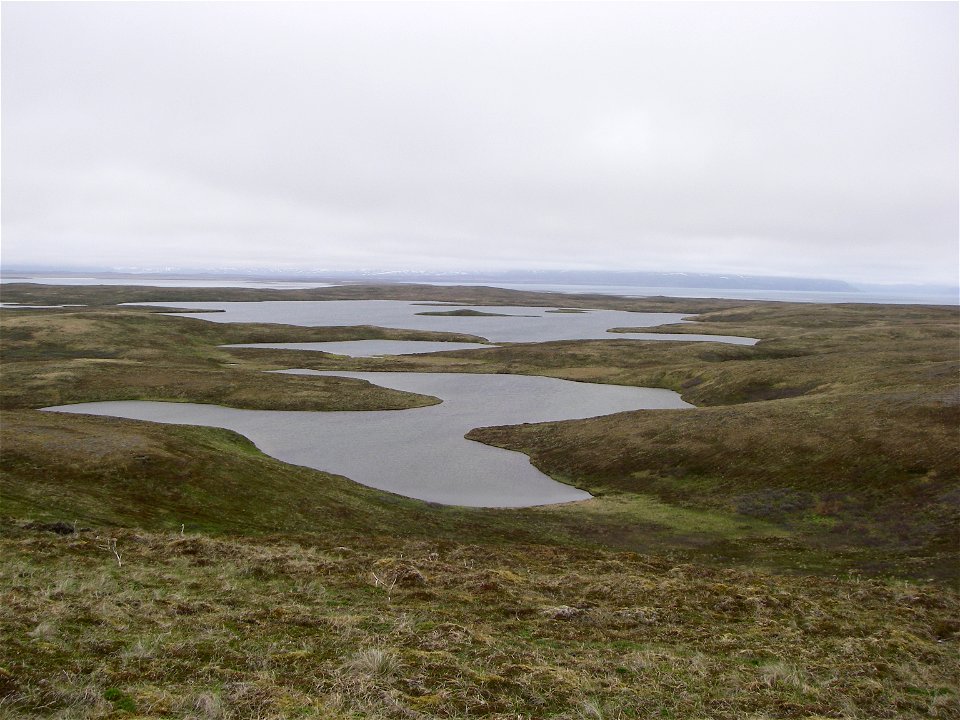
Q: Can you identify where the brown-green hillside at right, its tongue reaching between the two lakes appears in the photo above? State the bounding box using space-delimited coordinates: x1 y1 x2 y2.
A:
216 296 960 581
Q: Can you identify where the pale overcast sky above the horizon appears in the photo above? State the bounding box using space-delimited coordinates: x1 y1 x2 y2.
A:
2 2 960 283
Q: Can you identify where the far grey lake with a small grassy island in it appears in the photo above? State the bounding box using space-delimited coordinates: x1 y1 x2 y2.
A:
133 300 757 349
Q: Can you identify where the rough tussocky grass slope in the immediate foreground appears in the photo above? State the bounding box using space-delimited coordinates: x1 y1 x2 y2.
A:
0 523 960 719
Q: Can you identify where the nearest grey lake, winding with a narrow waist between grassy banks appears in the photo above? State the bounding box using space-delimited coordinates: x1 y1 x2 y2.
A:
44 370 693 507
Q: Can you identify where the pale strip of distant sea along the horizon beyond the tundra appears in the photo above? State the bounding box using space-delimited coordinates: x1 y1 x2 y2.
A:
0 274 960 305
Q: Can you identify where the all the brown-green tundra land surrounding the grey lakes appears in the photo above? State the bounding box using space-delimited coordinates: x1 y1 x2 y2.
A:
0 285 960 720
